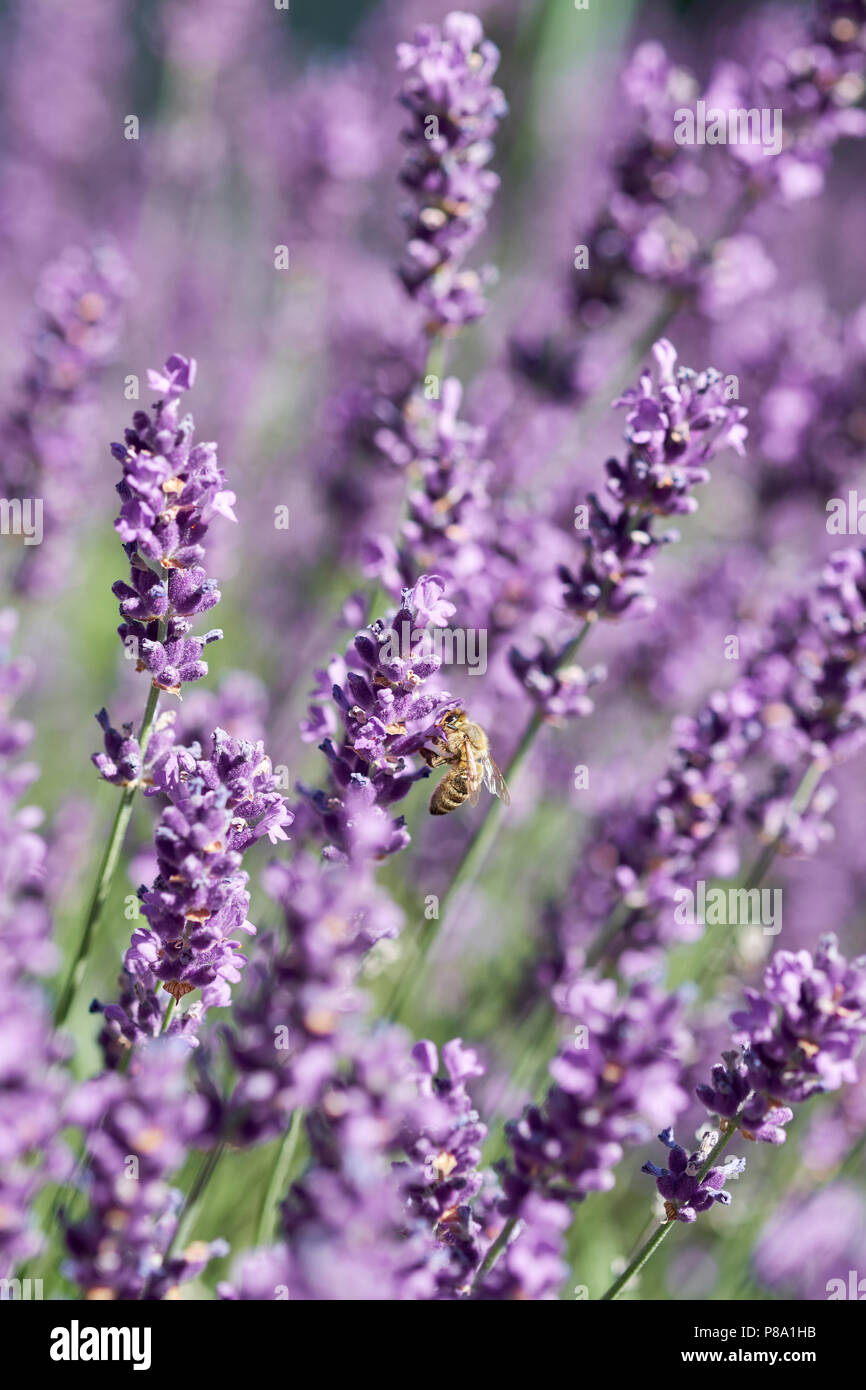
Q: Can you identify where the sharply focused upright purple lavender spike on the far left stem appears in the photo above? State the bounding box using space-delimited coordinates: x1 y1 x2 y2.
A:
111 353 236 695
